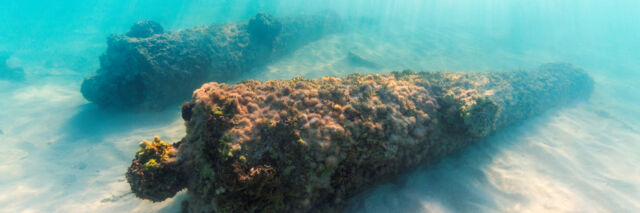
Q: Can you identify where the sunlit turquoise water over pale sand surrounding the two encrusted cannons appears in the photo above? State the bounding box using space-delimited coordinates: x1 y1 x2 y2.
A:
0 0 640 212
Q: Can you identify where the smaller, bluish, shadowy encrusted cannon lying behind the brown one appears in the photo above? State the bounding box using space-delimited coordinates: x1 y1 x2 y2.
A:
81 12 341 109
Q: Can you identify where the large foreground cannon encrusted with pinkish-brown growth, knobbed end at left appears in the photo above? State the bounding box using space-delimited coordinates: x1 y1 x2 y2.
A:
126 64 593 212
